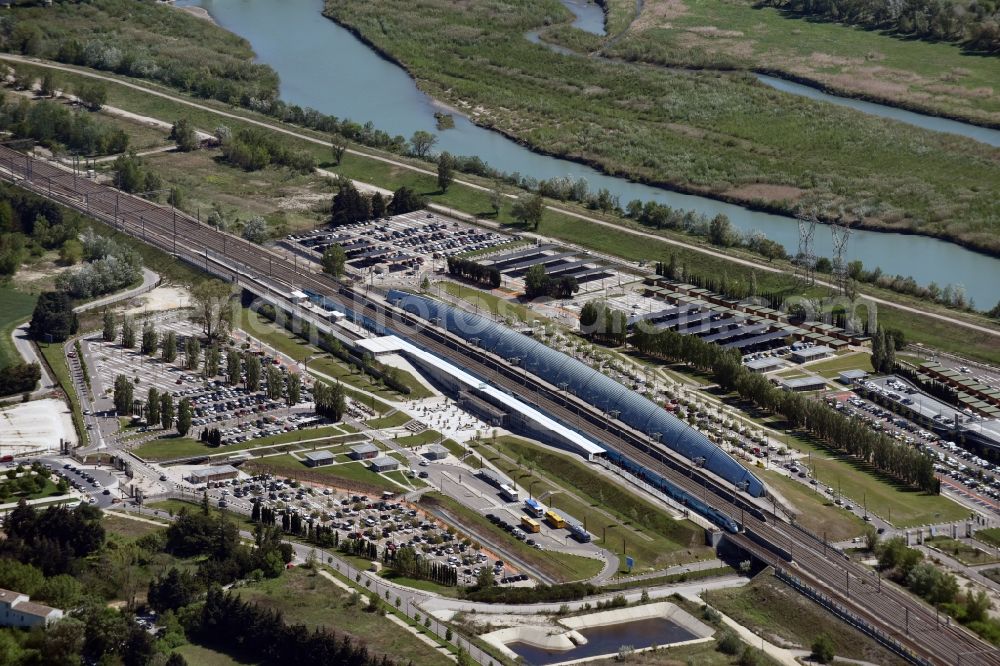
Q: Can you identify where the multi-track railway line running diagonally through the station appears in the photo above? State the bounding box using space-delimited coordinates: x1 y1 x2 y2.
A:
0 146 1000 666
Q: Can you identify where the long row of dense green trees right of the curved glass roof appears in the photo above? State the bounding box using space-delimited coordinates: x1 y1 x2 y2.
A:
630 326 940 493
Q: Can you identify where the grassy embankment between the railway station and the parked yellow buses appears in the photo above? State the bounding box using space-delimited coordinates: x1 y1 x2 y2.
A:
488 436 713 571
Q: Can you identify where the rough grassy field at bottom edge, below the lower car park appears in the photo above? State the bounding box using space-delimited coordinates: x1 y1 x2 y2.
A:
236 568 452 666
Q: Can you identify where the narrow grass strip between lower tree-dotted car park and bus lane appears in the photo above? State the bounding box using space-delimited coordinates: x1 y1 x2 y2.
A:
420 492 603 582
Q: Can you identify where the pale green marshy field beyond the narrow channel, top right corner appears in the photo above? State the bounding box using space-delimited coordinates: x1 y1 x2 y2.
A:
600 0 1000 123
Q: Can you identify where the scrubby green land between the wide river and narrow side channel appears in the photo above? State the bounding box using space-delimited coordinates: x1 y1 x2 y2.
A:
326 0 1000 252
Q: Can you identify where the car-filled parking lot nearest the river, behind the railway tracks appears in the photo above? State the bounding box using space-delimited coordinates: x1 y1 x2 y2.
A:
287 210 519 272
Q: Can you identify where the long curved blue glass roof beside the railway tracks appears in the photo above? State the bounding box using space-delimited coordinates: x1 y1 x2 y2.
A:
388 290 764 497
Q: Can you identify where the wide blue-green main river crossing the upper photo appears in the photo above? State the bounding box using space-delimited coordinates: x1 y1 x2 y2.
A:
177 0 1000 307
